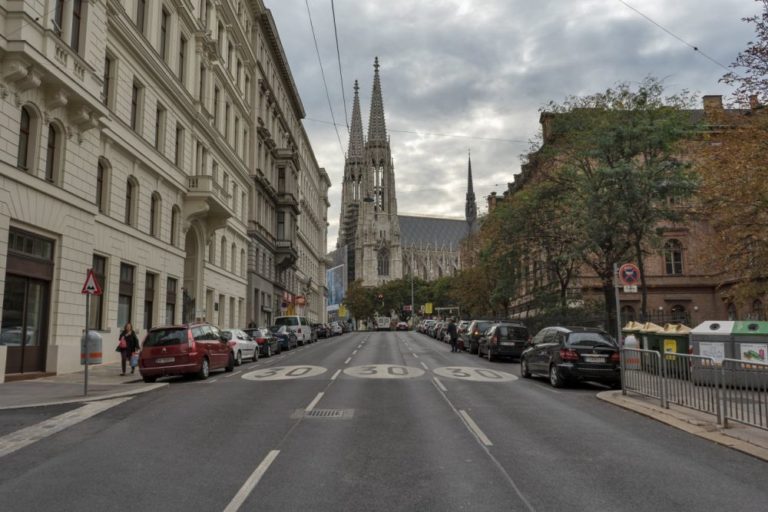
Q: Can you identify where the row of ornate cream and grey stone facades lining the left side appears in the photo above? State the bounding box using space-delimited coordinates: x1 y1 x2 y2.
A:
0 0 327 381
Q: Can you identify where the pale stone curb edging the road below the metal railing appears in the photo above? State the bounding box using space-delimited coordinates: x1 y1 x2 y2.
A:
597 391 768 462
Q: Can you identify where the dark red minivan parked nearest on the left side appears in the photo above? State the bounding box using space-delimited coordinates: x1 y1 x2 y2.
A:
139 323 235 382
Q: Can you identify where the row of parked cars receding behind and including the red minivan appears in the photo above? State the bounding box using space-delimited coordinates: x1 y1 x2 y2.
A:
139 316 342 382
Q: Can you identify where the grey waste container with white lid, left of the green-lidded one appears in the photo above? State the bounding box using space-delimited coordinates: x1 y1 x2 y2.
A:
689 320 736 384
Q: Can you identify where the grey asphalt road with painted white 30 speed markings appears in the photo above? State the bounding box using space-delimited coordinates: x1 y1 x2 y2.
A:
0 332 768 512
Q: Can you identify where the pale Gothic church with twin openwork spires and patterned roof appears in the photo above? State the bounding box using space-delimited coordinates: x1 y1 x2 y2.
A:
331 57 477 286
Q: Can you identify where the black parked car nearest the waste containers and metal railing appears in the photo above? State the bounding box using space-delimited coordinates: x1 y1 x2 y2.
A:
520 327 621 388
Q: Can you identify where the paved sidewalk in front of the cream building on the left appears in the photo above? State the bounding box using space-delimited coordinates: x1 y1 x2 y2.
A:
0 363 168 410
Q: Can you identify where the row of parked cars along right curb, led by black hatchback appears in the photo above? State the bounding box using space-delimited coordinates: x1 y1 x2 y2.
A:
417 319 621 387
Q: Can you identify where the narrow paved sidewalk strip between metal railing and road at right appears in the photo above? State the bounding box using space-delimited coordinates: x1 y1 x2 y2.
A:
597 391 768 462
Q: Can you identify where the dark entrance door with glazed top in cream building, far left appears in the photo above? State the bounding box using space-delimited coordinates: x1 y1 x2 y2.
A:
0 274 50 374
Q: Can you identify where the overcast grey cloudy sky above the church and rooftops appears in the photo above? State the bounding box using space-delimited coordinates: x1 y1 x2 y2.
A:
265 0 762 249
